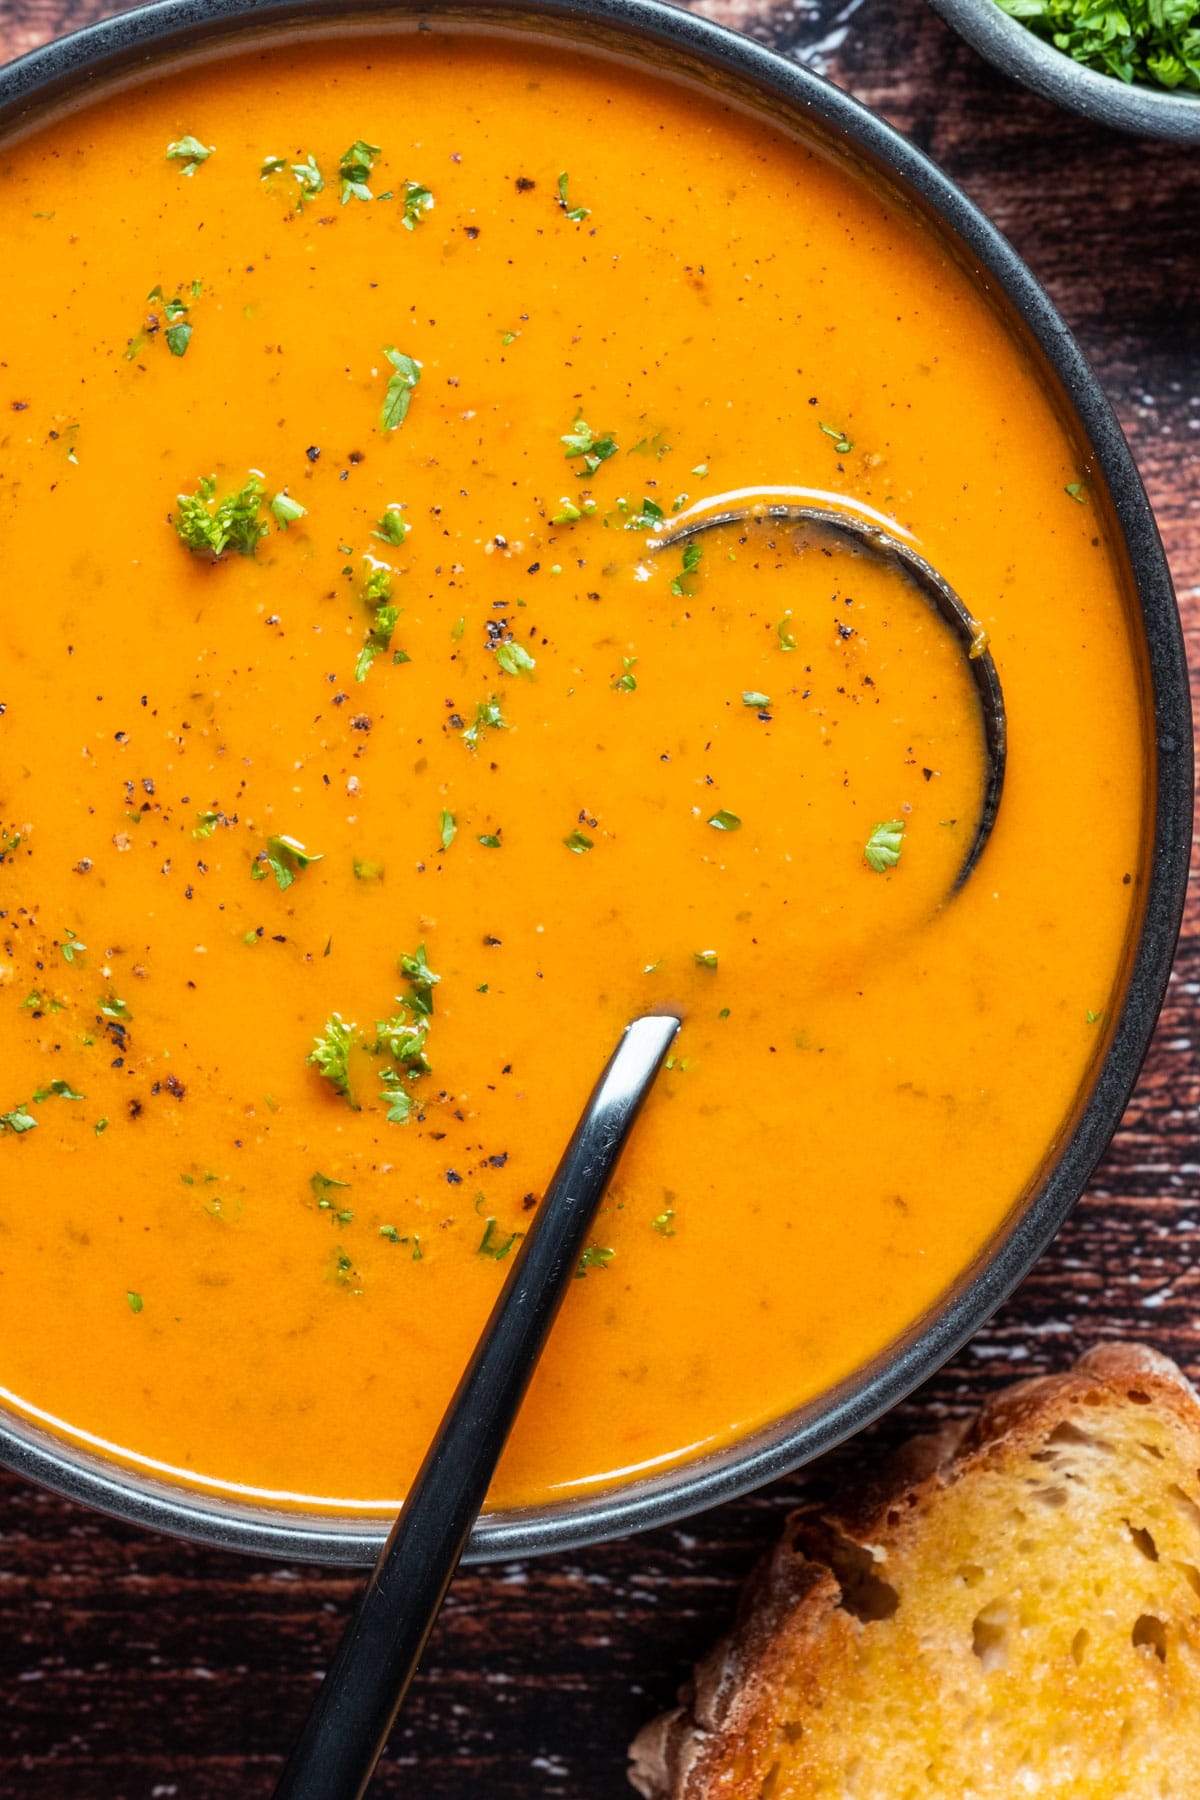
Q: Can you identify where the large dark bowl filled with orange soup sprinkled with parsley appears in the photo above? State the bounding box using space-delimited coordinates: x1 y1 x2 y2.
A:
0 0 1191 1561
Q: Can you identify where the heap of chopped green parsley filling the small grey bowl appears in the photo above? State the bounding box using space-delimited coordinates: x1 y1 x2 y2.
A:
999 0 1200 92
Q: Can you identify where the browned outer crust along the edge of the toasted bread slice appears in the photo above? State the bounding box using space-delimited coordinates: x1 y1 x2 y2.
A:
630 1343 1200 1800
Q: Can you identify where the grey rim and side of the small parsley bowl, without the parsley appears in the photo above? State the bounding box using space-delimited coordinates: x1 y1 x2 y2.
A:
930 0 1200 144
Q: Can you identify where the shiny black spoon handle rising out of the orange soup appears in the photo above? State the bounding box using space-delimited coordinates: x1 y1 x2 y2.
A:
275 1013 680 1800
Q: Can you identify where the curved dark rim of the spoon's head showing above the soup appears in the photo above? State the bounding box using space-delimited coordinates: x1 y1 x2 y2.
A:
646 488 1007 895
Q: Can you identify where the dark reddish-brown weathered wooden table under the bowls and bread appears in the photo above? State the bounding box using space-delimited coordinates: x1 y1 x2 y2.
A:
0 0 1200 1800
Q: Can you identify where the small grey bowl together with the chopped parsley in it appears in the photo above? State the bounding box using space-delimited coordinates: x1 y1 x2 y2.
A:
932 0 1200 142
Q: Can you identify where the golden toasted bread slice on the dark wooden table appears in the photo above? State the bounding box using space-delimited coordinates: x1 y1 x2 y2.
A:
630 1345 1200 1800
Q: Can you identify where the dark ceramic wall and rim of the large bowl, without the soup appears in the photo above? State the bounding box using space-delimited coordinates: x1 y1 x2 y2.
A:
0 0 1191 1562
